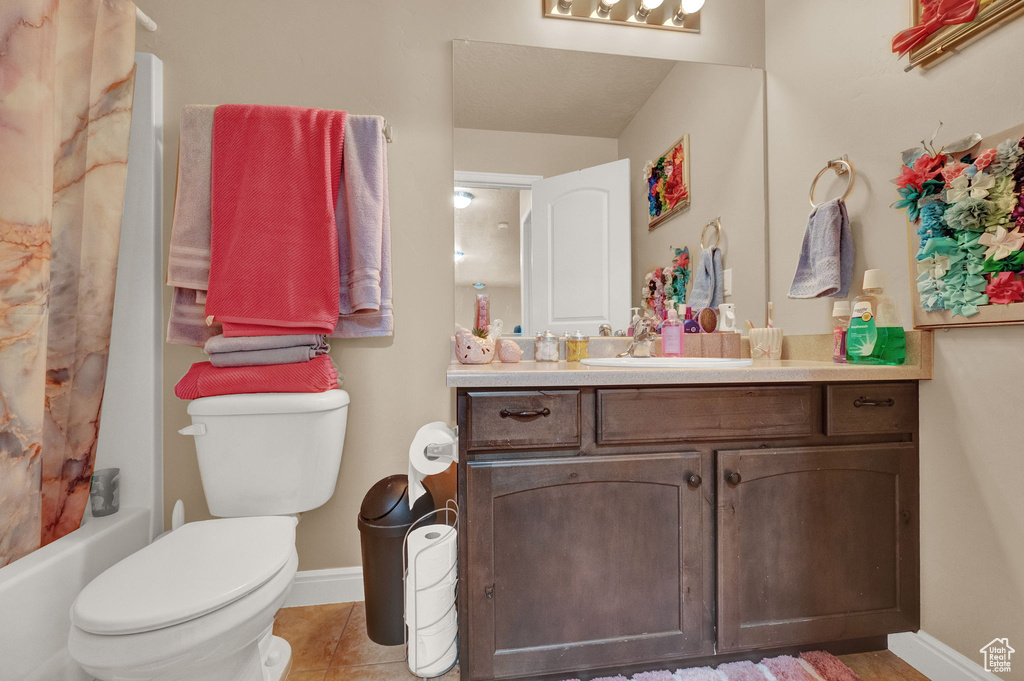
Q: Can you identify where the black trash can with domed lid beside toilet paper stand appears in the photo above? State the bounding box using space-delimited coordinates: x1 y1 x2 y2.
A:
358 475 434 645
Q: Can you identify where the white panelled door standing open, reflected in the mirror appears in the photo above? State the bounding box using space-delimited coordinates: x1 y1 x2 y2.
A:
523 159 630 335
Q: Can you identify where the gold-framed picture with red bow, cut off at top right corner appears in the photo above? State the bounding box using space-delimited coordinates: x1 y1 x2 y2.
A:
893 0 1024 71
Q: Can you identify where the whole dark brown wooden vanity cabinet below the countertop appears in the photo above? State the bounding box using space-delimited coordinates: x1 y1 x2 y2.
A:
458 381 919 681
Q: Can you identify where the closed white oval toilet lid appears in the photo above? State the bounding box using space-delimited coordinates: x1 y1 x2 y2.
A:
72 516 296 634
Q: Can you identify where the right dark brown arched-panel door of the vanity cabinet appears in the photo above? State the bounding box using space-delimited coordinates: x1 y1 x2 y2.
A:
717 442 920 651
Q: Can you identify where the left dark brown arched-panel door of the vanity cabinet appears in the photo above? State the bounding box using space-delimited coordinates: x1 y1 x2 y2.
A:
460 454 707 679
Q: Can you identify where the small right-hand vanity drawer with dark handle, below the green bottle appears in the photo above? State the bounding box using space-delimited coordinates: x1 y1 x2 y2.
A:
825 383 918 435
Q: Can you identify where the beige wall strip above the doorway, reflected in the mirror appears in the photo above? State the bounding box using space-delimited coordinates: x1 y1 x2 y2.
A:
455 128 618 177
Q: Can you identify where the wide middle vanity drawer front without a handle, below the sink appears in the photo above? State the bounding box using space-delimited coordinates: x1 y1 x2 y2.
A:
597 385 820 443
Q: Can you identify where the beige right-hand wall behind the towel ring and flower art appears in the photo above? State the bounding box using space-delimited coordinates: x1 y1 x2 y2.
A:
766 0 1024 679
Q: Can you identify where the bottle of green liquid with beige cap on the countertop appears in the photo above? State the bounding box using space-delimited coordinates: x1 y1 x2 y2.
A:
846 269 906 367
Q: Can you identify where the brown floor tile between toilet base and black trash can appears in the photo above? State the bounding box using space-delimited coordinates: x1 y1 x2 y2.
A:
273 603 352 681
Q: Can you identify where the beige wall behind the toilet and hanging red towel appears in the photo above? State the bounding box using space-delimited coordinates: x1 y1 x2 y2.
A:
137 0 764 569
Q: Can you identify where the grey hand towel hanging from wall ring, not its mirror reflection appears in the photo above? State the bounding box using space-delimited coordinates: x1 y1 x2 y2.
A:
790 199 853 298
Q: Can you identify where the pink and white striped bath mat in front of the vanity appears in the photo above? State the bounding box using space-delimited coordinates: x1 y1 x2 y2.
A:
566 650 863 681
